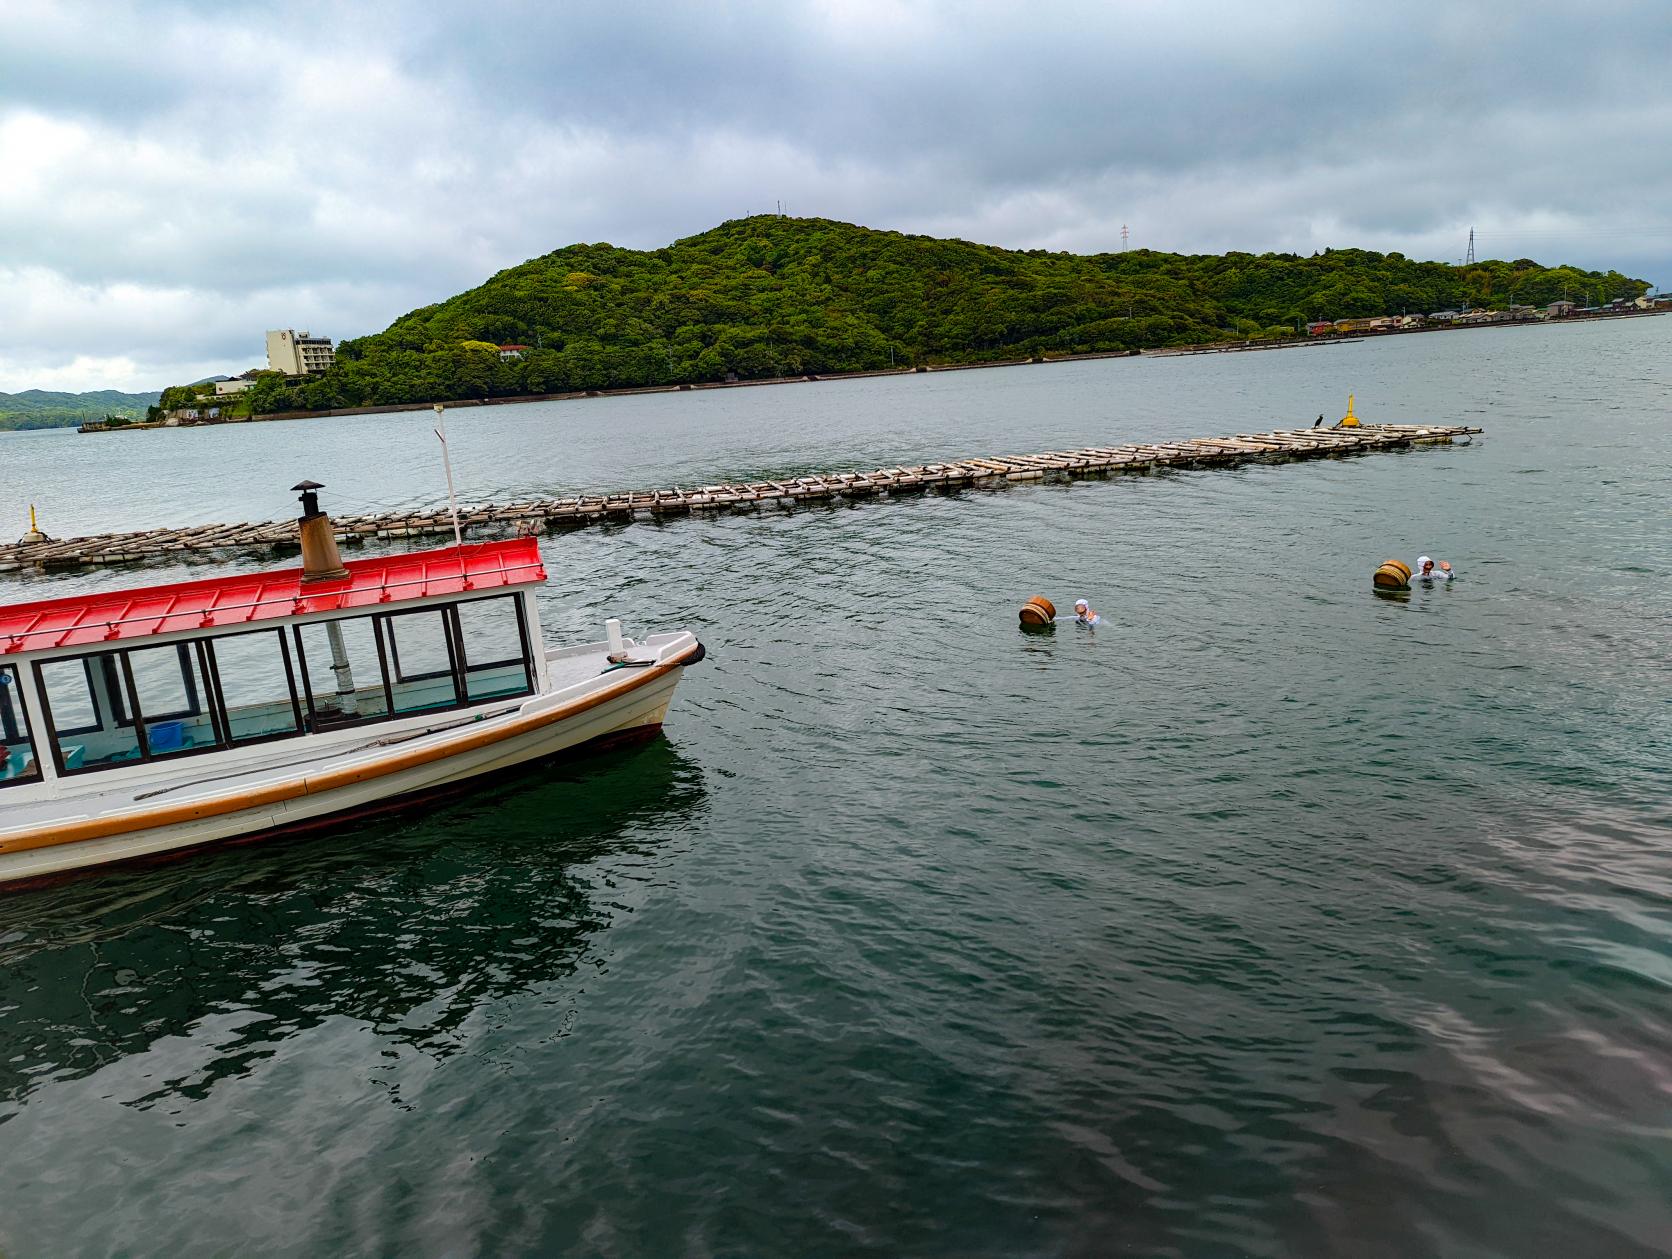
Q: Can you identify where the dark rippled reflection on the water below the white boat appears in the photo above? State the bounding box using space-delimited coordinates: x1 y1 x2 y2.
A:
0 739 706 1122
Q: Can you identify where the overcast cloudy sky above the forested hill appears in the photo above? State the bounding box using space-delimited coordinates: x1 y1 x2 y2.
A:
0 0 1672 391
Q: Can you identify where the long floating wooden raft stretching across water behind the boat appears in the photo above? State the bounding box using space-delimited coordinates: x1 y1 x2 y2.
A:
0 425 1481 572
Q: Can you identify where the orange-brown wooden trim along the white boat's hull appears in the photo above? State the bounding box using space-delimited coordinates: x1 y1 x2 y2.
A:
0 644 702 879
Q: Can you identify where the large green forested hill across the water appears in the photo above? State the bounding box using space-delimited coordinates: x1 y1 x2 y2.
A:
251 216 1649 411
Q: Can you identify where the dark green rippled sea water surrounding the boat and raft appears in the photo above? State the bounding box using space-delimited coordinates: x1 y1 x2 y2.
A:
0 319 1672 1259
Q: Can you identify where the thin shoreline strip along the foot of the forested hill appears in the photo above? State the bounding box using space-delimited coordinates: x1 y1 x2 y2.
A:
65 311 1672 433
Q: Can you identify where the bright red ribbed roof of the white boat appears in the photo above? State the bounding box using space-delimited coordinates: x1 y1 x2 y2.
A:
0 538 545 655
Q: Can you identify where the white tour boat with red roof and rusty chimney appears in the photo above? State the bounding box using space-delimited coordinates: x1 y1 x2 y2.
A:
0 483 704 883
